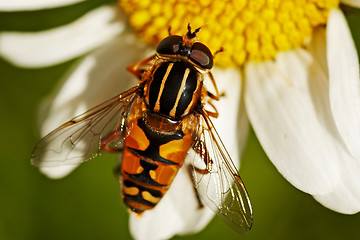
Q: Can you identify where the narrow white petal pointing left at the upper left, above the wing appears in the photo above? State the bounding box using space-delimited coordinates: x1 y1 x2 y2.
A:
0 6 125 67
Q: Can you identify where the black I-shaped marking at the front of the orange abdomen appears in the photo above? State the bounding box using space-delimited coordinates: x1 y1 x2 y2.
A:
128 118 184 165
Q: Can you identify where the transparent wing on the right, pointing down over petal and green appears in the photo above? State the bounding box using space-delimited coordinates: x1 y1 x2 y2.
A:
191 112 253 233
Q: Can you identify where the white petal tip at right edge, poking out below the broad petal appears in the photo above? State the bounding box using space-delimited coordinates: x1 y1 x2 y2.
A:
314 150 360 214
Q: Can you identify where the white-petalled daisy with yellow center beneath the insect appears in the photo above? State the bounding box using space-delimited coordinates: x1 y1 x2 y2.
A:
0 0 360 239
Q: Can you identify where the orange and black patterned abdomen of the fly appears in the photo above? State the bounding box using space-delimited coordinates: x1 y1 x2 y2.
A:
121 117 193 213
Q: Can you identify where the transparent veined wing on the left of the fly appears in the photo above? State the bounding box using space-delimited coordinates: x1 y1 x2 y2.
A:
31 86 139 167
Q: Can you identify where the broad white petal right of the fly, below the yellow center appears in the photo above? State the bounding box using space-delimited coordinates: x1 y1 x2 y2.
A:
245 49 344 194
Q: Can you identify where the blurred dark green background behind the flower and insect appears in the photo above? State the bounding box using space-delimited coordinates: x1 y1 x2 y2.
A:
0 0 360 240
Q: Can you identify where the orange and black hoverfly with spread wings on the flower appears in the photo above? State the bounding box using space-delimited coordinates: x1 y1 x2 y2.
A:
32 24 252 232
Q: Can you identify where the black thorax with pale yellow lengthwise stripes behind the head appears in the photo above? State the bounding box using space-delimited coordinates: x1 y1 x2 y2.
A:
145 62 202 119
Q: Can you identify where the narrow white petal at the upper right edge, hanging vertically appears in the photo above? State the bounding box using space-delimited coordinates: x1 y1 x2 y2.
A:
327 9 360 158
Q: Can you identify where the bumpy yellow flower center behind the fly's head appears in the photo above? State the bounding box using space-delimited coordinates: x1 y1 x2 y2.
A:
120 0 339 67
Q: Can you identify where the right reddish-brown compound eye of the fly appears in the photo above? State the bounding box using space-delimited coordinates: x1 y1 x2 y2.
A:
189 42 213 69
